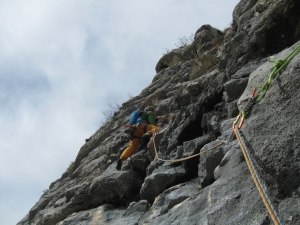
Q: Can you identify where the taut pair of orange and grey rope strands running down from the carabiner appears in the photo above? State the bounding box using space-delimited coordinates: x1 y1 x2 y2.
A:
232 124 281 225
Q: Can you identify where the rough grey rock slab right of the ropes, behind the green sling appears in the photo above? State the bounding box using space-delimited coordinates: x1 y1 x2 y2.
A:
238 42 300 224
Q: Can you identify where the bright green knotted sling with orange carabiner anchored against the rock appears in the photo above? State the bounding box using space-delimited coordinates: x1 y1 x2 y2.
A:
237 45 300 129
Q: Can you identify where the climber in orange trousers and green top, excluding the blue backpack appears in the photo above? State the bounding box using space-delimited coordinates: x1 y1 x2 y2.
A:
116 106 162 170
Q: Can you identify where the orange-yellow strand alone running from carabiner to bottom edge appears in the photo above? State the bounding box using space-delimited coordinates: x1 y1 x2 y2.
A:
232 124 279 225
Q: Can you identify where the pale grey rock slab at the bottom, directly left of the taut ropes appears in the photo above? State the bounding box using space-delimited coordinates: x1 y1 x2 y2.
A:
207 141 266 224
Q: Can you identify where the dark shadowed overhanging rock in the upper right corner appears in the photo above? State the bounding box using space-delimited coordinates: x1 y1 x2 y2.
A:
219 0 300 78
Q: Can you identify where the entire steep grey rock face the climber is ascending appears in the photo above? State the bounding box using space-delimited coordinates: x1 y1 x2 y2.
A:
18 0 300 225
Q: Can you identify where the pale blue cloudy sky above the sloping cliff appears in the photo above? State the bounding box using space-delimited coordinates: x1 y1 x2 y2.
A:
0 0 239 225
